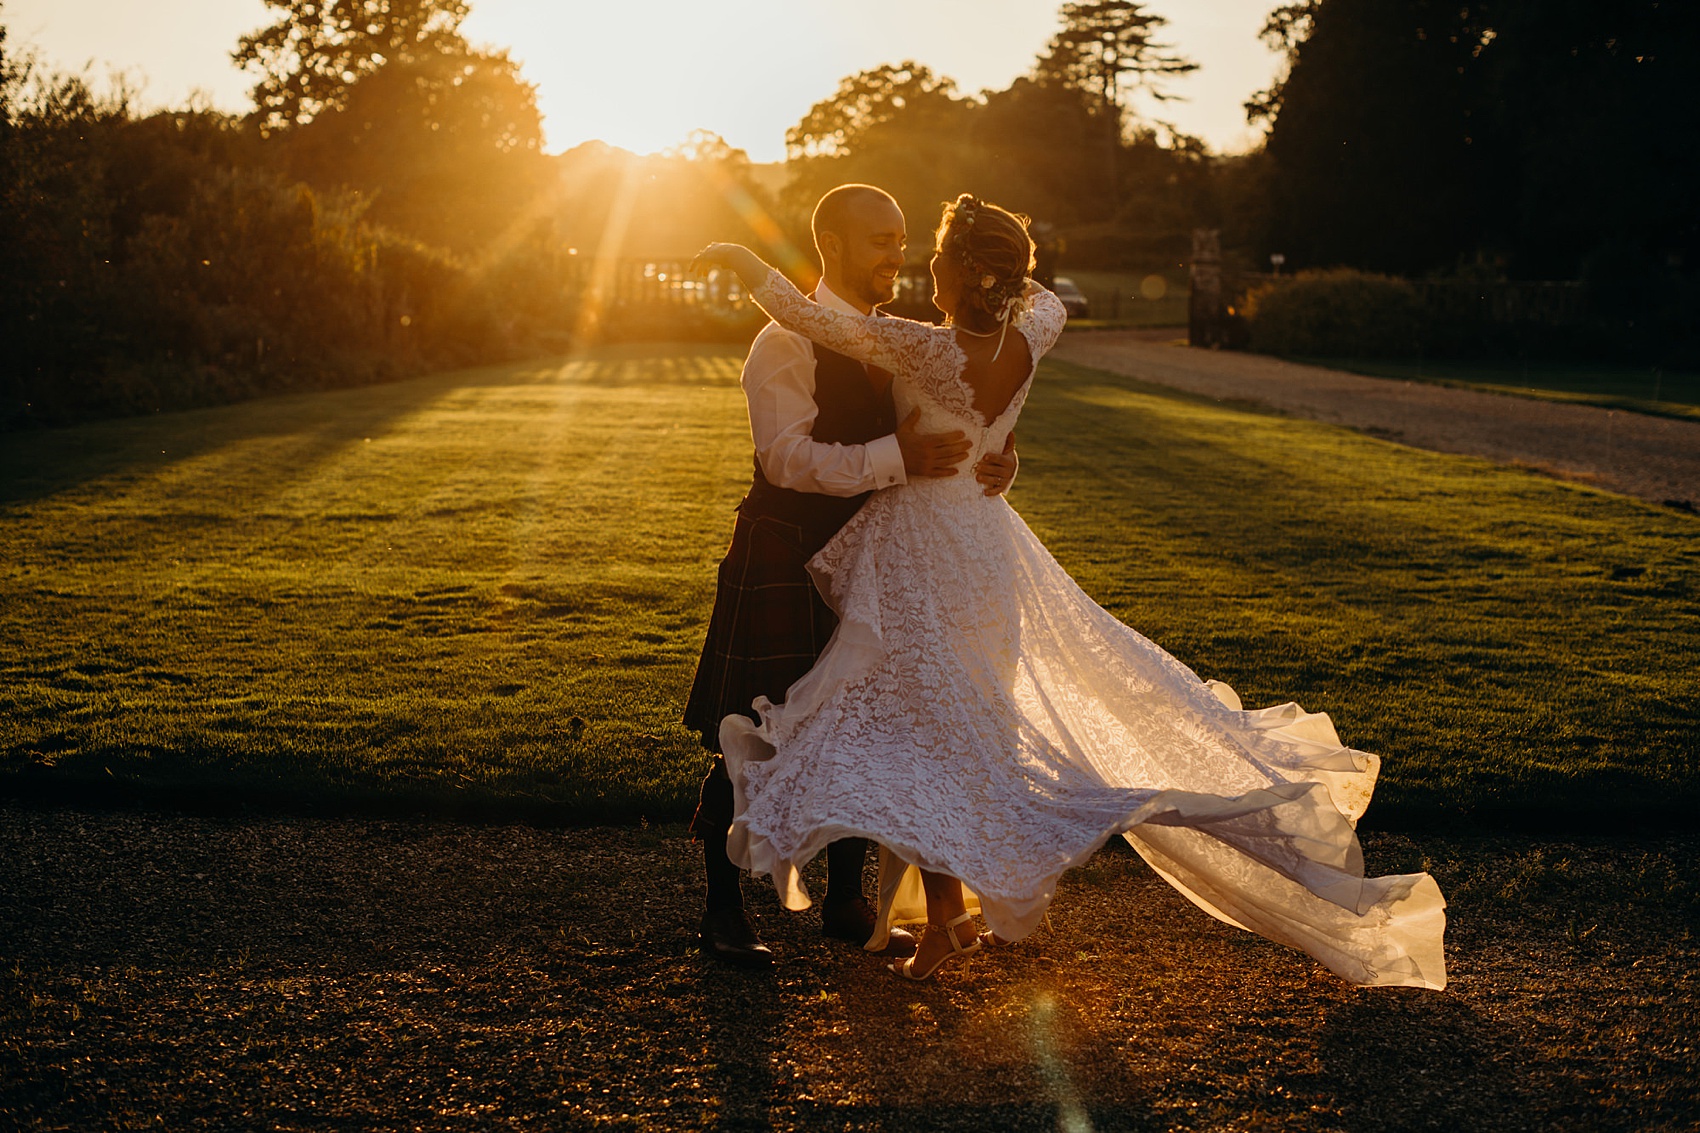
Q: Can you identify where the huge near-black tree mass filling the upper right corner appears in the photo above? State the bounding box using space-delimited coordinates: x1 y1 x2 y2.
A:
1248 0 1700 279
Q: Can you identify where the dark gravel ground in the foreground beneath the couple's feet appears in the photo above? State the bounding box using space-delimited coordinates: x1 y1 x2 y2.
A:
0 805 1700 1133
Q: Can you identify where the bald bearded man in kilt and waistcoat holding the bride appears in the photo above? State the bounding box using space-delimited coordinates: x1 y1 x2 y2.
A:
685 185 1017 966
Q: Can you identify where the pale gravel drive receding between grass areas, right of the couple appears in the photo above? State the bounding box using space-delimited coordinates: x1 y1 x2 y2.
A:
1052 330 1700 507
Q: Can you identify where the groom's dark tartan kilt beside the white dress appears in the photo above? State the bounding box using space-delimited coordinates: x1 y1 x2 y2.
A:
685 509 842 752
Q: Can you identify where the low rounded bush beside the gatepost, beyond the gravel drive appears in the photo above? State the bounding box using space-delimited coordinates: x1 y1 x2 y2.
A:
1244 269 1425 357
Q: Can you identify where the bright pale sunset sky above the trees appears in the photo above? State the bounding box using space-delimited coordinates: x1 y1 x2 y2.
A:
0 0 1278 162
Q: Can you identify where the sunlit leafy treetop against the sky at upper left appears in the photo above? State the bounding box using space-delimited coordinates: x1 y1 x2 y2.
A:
231 0 471 131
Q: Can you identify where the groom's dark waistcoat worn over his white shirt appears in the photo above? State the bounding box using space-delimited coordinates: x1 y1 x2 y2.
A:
738 344 898 555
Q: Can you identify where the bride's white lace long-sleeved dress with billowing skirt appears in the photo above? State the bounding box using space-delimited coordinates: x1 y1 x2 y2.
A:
721 272 1445 988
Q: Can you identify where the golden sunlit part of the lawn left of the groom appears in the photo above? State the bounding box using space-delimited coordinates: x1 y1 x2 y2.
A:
0 347 748 817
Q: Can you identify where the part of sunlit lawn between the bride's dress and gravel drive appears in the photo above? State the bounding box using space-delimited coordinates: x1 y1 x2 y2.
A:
1017 364 1700 822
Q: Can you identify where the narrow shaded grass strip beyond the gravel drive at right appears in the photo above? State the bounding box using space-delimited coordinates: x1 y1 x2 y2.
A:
1297 357 1700 420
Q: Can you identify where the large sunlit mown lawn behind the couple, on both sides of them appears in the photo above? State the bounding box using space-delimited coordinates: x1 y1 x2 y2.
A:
0 345 1700 830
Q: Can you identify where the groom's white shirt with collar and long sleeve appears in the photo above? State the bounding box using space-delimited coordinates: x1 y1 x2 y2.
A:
740 281 906 495
